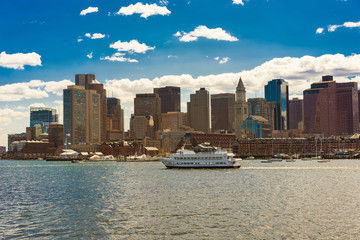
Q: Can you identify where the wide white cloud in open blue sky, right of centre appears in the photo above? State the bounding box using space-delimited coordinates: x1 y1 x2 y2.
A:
174 25 239 42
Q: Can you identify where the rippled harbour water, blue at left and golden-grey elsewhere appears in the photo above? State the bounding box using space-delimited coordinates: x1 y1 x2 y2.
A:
0 160 360 239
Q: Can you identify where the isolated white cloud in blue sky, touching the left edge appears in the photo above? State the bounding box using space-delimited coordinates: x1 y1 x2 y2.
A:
0 52 41 69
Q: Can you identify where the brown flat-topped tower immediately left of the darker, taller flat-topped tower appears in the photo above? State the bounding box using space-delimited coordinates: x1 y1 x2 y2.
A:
134 93 161 131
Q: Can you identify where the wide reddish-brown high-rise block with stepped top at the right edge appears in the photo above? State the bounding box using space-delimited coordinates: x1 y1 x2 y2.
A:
304 76 359 137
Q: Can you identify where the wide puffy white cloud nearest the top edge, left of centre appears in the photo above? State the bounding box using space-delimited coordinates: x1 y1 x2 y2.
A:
116 2 171 18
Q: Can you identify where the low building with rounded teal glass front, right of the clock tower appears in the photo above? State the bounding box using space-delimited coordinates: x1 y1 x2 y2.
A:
242 115 271 138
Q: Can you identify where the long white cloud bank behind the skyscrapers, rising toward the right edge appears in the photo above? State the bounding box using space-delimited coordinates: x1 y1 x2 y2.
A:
105 54 360 103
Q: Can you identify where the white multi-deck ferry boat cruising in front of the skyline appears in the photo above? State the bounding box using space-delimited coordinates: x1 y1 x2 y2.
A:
161 143 241 168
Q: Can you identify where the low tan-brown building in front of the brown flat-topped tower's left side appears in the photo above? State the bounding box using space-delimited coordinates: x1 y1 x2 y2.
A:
130 114 155 139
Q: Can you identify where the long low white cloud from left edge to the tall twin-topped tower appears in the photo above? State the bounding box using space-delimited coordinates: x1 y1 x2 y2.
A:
0 79 73 102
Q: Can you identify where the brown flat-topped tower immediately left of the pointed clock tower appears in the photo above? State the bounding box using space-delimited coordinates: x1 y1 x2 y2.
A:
211 93 235 132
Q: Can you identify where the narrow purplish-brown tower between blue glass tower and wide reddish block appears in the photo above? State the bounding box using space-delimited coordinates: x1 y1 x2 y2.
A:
289 98 304 129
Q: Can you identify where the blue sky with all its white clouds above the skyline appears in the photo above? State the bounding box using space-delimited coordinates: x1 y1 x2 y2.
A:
0 0 360 146
